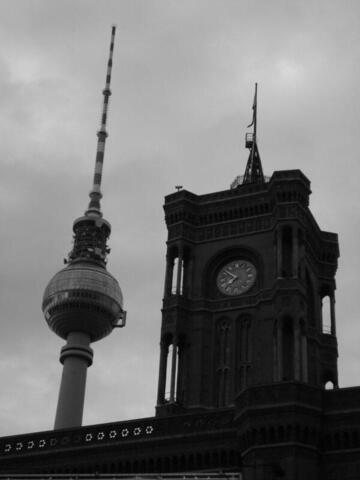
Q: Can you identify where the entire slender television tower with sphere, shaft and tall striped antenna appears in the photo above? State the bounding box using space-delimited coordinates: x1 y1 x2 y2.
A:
42 27 125 429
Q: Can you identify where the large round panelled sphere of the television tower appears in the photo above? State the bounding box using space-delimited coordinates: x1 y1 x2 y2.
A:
42 260 123 342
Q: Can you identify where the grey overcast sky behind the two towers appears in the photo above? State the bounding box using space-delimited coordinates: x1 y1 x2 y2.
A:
0 0 360 435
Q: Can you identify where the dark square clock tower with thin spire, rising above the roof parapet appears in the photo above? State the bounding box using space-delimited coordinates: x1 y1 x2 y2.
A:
157 86 339 416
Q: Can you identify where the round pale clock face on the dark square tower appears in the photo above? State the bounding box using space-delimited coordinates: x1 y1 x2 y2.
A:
216 260 256 295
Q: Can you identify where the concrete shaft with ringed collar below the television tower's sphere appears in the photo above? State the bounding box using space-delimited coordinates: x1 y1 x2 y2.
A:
54 332 93 430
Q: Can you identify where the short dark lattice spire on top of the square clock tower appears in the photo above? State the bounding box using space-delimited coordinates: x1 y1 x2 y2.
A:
243 83 265 183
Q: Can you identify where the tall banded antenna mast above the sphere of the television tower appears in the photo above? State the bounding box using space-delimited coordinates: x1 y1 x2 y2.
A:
86 25 116 217
